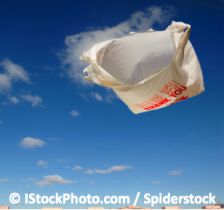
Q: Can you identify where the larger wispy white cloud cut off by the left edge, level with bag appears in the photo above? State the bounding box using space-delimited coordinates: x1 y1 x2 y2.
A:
0 59 30 93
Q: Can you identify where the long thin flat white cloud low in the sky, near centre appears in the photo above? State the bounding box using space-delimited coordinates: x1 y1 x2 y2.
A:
85 165 132 175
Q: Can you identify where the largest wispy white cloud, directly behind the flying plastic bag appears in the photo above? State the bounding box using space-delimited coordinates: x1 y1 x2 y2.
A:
60 6 174 84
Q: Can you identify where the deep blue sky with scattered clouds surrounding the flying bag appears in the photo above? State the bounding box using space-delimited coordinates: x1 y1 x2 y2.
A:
0 0 224 208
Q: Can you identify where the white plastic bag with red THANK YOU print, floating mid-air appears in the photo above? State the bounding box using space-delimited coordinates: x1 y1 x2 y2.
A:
81 21 204 114
